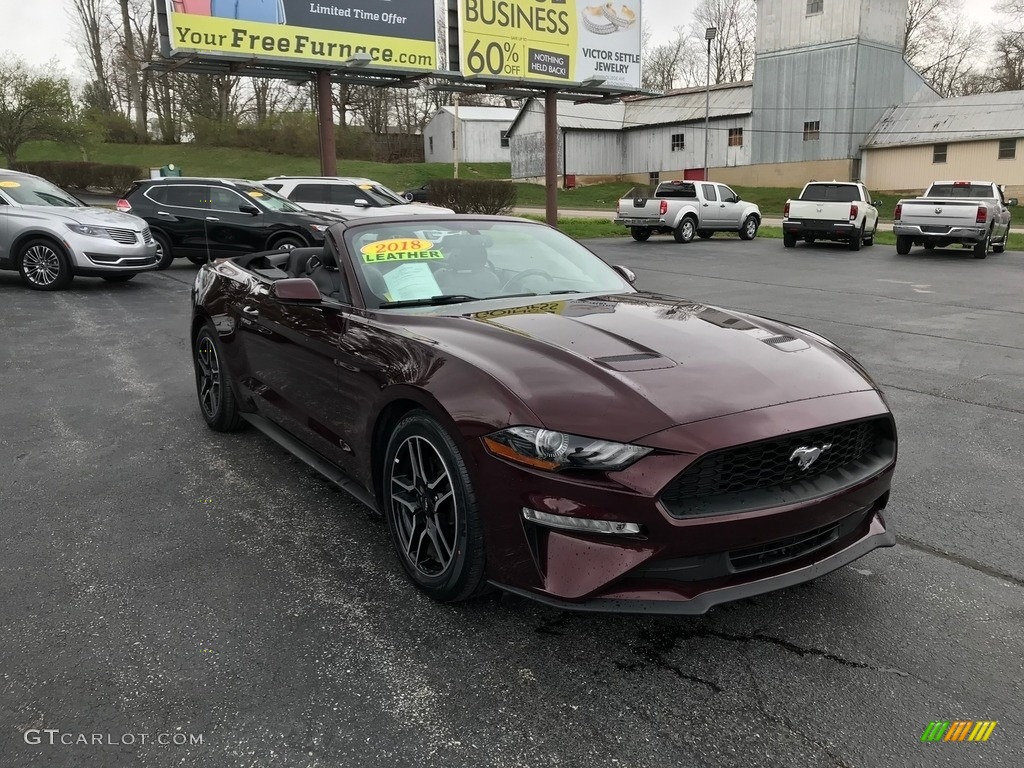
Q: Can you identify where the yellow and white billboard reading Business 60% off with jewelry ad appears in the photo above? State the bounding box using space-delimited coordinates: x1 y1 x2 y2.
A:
459 0 640 90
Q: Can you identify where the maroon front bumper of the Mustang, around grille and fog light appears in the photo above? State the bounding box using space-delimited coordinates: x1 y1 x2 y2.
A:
471 392 895 613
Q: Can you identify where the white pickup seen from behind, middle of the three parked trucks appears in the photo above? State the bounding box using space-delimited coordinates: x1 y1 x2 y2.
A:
782 181 879 251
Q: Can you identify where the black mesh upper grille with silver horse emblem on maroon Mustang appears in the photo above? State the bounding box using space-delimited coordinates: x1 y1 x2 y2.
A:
662 418 896 517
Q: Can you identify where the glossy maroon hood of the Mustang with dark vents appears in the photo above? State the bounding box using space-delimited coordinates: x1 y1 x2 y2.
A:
395 294 874 440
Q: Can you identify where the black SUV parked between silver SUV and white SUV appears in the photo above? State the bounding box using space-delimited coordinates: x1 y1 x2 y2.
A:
118 176 342 269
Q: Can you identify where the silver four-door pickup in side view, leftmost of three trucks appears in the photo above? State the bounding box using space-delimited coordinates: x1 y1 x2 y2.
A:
615 181 761 243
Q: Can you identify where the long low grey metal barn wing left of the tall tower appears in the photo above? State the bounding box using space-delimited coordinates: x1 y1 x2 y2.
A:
510 83 752 182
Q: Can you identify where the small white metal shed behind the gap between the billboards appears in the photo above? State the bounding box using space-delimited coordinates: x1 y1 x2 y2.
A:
423 106 519 163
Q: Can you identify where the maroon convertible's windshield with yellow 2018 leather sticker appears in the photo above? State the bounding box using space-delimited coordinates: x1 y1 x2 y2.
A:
345 220 634 308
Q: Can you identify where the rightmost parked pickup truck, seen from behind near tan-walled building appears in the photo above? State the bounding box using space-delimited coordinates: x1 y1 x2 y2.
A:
893 181 1017 259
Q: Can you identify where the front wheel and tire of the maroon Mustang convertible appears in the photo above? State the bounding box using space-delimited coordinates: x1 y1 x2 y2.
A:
382 411 486 602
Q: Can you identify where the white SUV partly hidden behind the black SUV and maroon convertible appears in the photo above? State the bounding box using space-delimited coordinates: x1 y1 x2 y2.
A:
259 176 455 218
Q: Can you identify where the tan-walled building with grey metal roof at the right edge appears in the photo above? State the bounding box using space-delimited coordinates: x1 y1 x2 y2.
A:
861 91 1024 198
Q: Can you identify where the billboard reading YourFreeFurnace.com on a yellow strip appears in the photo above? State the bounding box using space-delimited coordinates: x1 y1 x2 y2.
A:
167 0 437 72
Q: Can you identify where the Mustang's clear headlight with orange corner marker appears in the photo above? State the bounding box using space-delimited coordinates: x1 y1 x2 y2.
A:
483 427 651 472
